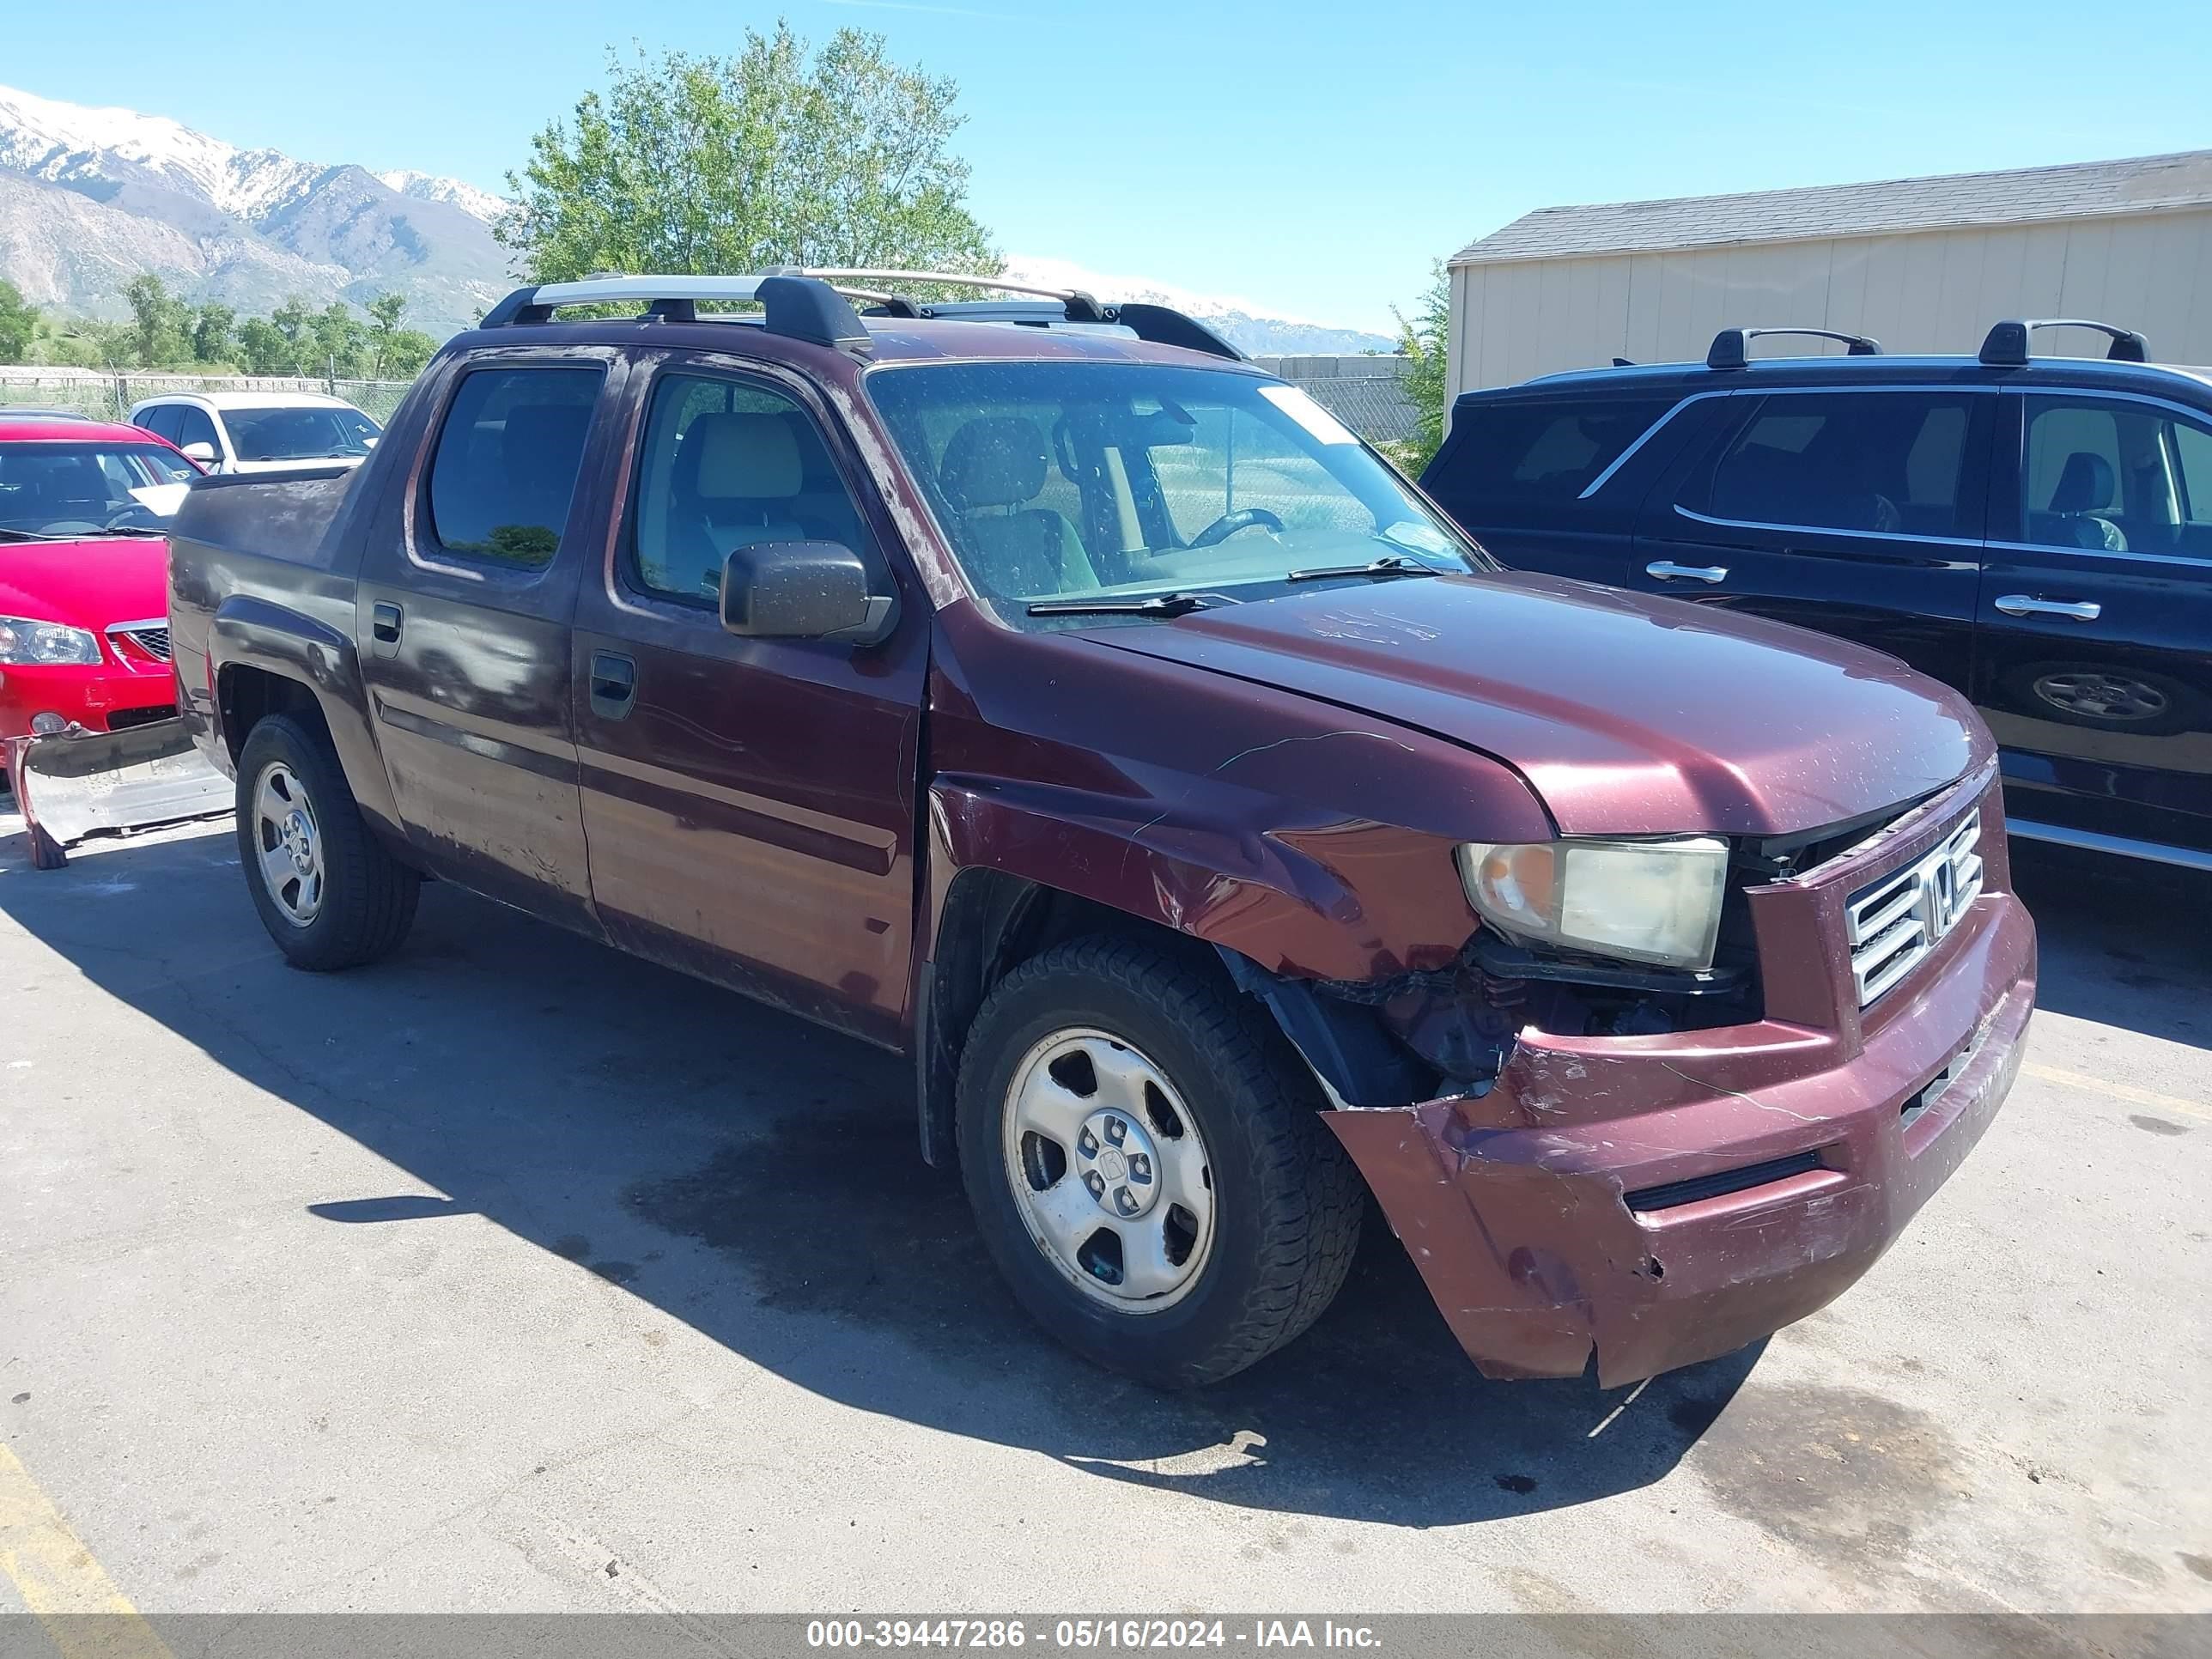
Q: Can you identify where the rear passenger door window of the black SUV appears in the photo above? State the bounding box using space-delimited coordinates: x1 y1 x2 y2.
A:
1681 392 1978 535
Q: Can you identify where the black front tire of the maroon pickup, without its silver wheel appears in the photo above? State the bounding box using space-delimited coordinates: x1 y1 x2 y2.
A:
957 938 1364 1387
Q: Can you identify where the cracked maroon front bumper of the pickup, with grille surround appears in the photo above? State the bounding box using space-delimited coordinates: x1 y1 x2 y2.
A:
1328 790 2035 1387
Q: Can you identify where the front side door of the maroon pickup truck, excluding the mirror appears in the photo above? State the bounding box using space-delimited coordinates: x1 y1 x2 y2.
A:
575 354 929 1042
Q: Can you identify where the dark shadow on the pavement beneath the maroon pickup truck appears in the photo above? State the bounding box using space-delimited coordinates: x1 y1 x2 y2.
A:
0 836 1759 1526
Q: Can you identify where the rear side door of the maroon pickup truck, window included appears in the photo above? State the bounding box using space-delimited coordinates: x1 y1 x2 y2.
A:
356 354 619 931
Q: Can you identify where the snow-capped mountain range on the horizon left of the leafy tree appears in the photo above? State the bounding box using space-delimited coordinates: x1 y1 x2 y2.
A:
0 86 511 334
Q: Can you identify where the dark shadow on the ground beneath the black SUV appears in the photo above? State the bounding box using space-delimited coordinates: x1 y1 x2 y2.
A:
2011 841 2212 1048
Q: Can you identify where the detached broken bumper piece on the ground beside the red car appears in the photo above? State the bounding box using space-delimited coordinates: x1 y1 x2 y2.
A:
7 719 234 869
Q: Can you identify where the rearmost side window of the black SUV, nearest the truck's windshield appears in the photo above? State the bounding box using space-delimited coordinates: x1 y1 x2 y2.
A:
1422 398 1674 525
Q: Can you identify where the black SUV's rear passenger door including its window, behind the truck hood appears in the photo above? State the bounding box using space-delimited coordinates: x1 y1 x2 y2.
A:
1628 387 1997 692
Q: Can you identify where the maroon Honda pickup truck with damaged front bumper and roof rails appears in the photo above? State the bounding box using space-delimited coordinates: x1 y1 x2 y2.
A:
170 272 2035 1385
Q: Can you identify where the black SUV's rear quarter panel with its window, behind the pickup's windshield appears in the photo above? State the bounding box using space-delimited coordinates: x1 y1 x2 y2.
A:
1420 392 1708 586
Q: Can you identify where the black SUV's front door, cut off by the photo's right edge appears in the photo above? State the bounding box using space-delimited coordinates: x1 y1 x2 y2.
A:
1975 387 2212 852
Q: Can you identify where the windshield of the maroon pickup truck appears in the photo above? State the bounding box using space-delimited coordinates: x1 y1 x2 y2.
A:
867 362 1489 629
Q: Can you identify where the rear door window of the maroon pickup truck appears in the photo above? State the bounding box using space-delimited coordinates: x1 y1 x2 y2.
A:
429 368 604 568
